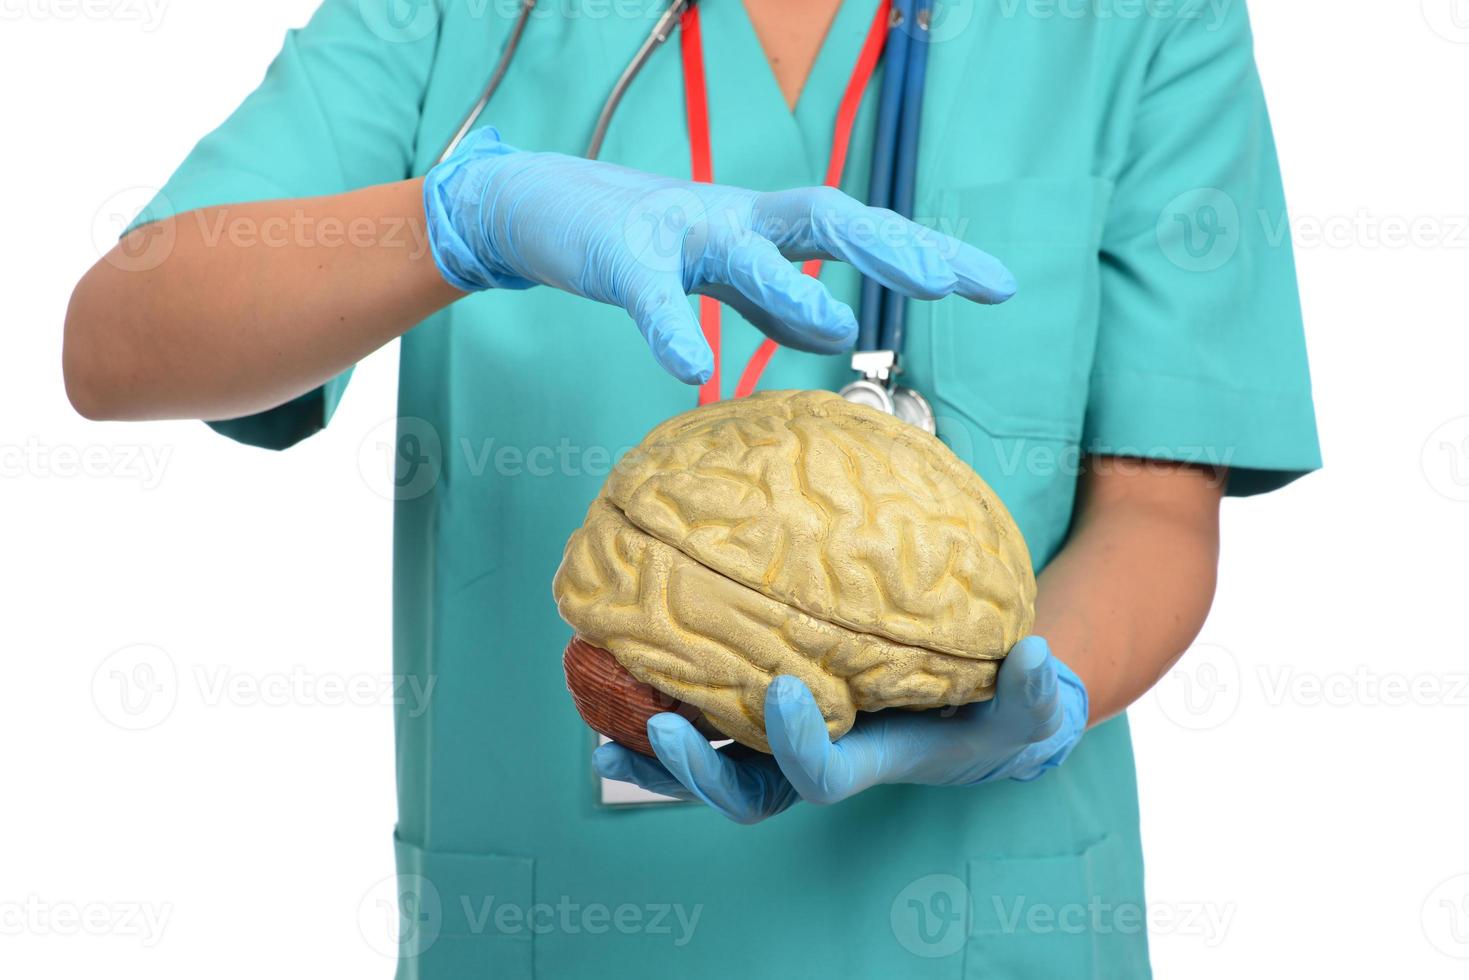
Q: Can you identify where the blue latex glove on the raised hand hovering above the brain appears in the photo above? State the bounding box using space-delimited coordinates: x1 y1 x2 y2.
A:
423 129 1015 383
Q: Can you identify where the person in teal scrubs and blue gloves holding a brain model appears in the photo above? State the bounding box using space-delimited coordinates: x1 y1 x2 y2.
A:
65 0 1318 980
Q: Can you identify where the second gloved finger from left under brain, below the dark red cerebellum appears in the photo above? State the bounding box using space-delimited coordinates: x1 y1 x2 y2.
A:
648 711 796 824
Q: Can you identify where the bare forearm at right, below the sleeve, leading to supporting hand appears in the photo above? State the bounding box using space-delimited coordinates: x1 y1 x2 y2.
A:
1036 458 1222 724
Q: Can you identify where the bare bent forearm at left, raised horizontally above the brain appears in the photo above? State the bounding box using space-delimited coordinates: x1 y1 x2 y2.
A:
63 181 463 419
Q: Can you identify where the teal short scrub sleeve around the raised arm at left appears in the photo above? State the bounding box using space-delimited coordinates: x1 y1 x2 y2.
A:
132 0 438 450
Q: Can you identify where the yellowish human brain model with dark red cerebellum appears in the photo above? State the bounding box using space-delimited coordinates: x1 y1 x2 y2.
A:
552 391 1036 754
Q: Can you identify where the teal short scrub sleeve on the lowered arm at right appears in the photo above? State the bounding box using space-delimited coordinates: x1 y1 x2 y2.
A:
1083 3 1321 495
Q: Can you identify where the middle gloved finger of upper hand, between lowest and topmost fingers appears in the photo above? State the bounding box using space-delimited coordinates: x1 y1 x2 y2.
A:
698 234 856 354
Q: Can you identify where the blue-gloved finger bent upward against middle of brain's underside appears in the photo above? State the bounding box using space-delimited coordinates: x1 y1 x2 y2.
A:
765 674 880 804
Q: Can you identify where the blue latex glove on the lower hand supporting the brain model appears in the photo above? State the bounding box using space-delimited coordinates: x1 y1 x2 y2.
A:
593 636 1089 823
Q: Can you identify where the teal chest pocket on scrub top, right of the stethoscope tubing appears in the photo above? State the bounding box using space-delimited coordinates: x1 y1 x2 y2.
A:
933 178 1111 444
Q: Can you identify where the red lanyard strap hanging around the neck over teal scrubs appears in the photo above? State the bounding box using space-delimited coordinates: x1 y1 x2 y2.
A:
679 0 890 406
